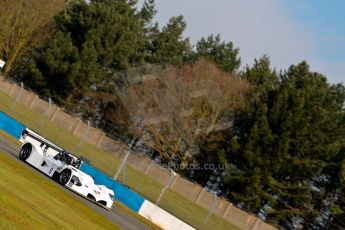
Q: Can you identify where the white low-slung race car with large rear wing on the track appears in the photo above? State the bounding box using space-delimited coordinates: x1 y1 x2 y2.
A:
19 130 114 209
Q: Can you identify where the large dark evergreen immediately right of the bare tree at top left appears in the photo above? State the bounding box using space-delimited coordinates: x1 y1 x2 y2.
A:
24 0 144 120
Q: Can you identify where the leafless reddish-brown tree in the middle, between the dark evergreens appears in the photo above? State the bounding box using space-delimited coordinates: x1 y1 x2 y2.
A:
117 60 249 162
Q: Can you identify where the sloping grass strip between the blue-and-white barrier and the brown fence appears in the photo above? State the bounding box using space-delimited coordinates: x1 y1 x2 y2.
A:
0 92 238 230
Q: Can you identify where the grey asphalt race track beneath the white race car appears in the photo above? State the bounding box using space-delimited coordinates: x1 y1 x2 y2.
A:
0 136 150 230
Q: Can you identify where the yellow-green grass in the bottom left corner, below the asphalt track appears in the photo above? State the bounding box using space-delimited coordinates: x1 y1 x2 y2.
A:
0 153 118 229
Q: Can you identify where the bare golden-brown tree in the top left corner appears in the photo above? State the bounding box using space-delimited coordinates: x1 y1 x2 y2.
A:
0 0 64 74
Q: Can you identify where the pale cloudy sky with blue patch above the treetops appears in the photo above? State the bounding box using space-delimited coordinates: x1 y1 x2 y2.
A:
139 0 345 83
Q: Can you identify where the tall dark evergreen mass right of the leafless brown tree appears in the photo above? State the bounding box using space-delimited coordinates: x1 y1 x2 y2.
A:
220 57 344 229
